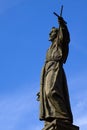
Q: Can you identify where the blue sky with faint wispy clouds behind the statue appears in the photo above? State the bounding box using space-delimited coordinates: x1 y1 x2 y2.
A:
0 0 87 130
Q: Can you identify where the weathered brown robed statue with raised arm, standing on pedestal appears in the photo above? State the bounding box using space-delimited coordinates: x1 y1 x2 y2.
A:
38 6 73 129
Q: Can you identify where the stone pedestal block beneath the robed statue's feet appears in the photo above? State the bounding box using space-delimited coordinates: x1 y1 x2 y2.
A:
42 119 79 130
